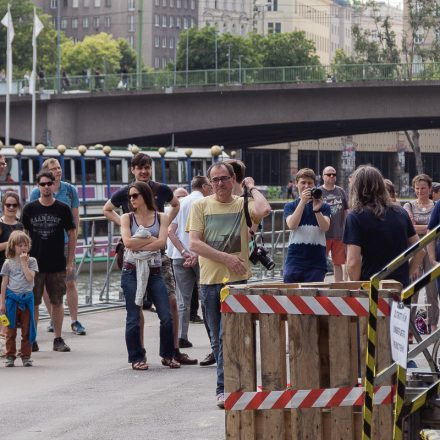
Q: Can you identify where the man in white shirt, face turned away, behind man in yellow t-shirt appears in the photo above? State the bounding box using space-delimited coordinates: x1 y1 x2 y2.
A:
168 176 212 343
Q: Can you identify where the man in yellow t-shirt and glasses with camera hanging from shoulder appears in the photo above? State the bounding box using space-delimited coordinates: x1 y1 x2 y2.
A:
186 162 271 408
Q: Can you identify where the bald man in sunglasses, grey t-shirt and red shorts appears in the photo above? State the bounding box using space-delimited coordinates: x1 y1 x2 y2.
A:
320 166 348 282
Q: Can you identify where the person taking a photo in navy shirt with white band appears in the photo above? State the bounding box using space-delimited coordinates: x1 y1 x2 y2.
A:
284 168 331 283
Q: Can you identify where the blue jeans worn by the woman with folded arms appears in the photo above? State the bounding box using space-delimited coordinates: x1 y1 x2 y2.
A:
121 269 174 362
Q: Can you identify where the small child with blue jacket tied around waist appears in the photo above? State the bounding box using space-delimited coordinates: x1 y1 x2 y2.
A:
0 231 38 367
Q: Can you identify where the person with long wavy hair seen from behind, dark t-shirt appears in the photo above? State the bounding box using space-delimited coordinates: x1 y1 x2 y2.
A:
343 165 423 286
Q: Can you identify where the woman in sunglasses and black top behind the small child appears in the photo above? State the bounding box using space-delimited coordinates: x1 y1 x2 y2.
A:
0 191 23 356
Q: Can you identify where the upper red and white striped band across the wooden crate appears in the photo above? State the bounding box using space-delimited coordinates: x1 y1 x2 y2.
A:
221 294 391 316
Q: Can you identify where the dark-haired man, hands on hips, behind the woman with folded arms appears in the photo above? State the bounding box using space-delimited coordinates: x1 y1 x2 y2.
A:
103 153 197 365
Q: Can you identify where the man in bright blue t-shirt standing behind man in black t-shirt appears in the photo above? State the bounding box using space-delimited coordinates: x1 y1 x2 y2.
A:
30 158 86 335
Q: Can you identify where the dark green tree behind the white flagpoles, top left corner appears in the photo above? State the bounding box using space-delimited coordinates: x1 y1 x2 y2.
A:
0 0 57 78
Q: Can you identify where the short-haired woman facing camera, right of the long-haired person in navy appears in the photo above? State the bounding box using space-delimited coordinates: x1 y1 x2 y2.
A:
403 174 439 331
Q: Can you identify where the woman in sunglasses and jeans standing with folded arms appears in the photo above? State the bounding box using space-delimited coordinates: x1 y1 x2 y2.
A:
121 182 180 370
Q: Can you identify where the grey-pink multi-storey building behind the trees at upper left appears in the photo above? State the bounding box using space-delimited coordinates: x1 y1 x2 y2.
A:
34 0 198 69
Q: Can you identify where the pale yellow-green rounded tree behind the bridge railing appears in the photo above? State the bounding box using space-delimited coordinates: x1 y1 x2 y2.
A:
61 32 122 75
